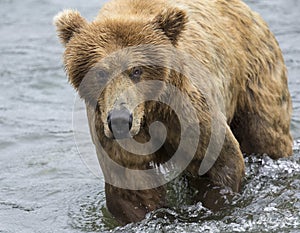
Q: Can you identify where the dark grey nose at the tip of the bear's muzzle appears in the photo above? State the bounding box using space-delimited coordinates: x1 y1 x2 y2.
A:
107 108 132 139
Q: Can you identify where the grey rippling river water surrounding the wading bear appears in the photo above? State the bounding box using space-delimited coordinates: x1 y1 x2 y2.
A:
0 0 300 233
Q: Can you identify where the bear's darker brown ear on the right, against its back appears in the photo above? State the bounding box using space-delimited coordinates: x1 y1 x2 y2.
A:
154 8 188 45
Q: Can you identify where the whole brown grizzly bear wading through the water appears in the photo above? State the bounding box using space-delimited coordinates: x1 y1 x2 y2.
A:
54 0 292 224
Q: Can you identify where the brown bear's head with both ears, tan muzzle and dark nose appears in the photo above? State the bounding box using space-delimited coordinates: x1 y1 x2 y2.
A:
54 8 187 139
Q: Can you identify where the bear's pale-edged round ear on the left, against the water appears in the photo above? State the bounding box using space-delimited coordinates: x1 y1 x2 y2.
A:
53 10 87 46
